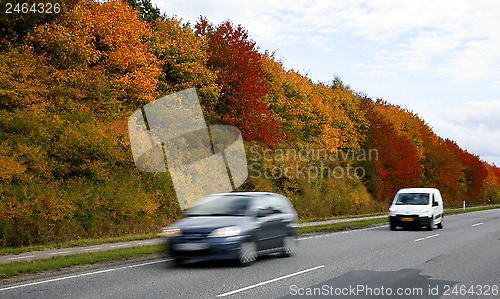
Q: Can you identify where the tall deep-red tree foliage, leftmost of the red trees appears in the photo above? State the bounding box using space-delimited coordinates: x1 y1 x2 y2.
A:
195 17 281 146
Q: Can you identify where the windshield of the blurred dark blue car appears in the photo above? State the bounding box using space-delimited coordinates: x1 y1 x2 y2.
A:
186 195 250 216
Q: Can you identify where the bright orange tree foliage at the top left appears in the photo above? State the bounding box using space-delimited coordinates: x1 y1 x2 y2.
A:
30 0 160 104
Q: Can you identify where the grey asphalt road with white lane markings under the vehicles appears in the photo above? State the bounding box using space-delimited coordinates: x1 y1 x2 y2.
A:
0 210 500 298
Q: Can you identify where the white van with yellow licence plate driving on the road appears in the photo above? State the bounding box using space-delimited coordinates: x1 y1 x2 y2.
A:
389 188 443 230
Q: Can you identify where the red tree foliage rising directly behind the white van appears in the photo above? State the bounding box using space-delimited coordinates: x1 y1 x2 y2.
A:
360 98 422 200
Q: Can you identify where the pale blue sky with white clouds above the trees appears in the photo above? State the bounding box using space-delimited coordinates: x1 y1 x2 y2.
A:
153 0 500 166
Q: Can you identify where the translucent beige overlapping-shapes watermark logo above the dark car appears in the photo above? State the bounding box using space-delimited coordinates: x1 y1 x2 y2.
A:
128 88 248 209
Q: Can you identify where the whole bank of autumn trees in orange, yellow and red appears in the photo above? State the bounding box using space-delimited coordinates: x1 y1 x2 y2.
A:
0 0 500 246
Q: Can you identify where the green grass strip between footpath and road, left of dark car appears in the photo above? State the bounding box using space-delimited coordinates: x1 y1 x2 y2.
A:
0 244 163 279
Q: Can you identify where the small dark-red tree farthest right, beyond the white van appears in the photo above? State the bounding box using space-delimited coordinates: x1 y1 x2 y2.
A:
445 139 488 200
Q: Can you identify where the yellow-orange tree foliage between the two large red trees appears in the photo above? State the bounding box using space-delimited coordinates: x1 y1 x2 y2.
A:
262 53 368 152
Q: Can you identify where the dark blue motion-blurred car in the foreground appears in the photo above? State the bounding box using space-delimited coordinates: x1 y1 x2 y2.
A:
162 192 298 265
